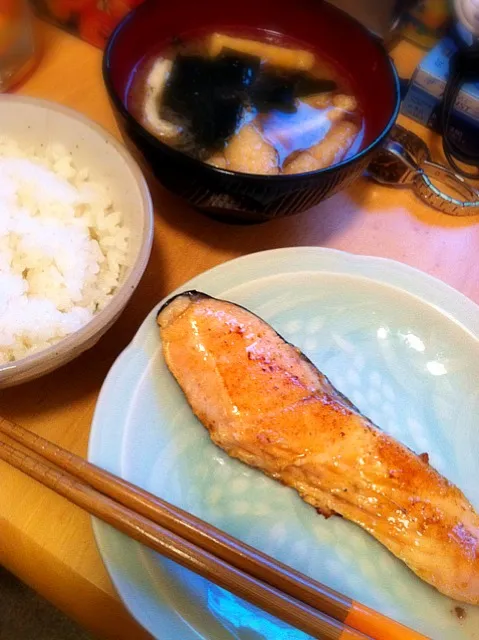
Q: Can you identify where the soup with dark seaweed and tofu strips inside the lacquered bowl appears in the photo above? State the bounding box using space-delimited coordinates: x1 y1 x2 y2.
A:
127 32 364 175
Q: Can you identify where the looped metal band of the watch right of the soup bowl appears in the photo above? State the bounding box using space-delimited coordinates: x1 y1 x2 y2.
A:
413 160 479 216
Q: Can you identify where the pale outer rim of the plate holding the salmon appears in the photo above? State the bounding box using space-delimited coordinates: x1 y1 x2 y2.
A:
87 246 479 638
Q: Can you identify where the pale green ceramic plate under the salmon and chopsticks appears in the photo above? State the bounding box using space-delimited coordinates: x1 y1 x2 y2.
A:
89 248 479 640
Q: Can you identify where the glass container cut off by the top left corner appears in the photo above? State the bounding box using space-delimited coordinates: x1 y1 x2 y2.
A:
0 0 35 92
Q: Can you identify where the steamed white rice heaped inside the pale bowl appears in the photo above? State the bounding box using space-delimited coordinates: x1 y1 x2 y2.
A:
0 137 129 365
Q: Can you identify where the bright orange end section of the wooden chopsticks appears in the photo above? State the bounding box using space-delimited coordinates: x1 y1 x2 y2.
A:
341 600 428 640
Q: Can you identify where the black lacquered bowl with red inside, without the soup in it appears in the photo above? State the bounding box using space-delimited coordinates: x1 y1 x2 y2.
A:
103 0 400 222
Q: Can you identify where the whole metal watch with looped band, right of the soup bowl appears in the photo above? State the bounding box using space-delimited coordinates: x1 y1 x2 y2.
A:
368 124 479 216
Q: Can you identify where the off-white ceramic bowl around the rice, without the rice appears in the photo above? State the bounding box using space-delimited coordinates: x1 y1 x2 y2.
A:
0 96 153 389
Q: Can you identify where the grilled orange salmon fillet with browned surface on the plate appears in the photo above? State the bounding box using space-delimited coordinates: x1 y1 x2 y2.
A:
158 291 479 604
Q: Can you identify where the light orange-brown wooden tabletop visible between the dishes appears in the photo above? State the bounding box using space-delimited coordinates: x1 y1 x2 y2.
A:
0 23 479 640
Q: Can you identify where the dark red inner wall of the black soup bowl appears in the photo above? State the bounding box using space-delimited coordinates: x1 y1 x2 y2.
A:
106 0 398 148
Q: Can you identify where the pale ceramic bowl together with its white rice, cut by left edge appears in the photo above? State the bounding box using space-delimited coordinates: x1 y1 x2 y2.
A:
0 96 153 389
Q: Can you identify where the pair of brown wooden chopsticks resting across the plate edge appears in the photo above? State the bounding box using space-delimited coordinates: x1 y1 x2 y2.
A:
0 418 425 640
